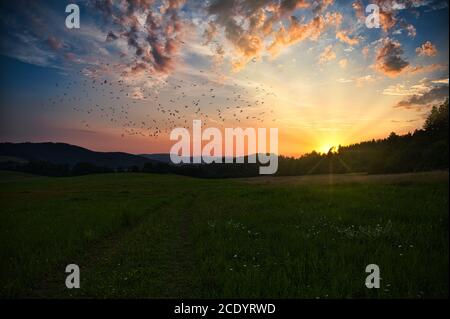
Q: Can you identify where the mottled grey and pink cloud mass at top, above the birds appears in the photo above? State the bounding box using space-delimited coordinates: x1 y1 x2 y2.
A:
88 0 189 84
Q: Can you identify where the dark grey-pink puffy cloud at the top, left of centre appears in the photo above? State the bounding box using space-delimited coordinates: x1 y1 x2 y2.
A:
95 0 186 75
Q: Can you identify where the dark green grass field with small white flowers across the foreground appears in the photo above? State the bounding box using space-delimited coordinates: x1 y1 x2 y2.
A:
0 172 449 298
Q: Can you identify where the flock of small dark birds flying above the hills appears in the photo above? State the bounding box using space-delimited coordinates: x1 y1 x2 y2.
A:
47 67 276 138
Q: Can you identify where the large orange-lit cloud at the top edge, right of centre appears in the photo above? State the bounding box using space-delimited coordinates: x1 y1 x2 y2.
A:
204 0 342 71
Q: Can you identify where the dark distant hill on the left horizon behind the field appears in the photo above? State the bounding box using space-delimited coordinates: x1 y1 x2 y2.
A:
0 143 152 169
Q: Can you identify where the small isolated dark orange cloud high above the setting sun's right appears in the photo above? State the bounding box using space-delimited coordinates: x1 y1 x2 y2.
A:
375 38 409 77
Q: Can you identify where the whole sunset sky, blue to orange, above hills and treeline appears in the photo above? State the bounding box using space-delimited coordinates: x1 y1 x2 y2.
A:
0 0 449 156
